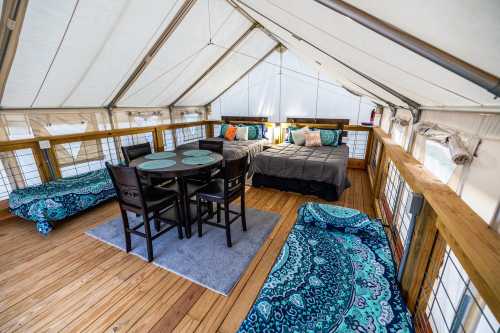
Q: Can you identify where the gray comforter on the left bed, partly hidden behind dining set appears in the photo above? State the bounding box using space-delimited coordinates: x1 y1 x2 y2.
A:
177 138 268 176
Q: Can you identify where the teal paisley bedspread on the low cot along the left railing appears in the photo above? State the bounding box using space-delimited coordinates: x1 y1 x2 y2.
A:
9 169 116 235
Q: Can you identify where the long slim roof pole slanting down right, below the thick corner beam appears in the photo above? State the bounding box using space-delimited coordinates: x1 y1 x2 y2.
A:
232 0 420 109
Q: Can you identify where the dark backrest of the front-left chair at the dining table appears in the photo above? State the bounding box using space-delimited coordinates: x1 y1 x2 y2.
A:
106 163 144 209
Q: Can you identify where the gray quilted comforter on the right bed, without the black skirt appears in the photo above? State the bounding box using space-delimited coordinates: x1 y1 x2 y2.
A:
253 143 349 185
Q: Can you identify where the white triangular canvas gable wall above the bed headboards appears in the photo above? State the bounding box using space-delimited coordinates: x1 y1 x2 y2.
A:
207 51 375 124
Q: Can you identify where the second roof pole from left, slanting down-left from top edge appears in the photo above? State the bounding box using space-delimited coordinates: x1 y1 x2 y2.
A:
108 0 196 107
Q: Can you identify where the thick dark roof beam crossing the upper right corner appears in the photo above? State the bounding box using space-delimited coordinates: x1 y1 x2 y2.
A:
314 0 500 97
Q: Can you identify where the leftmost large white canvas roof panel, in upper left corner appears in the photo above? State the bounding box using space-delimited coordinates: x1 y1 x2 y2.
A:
2 0 184 108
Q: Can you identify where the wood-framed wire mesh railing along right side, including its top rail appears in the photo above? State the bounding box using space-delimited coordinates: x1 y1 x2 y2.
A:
368 129 500 333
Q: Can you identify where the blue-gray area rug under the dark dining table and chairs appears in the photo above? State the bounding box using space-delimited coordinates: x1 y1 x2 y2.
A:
87 206 280 296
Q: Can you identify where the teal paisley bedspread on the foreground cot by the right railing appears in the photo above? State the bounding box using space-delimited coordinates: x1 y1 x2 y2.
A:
239 203 414 332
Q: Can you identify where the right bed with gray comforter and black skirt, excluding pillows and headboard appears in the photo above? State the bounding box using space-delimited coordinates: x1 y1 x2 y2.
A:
252 143 350 200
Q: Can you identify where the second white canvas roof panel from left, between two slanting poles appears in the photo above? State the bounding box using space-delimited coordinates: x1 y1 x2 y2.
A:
118 0 258 106
